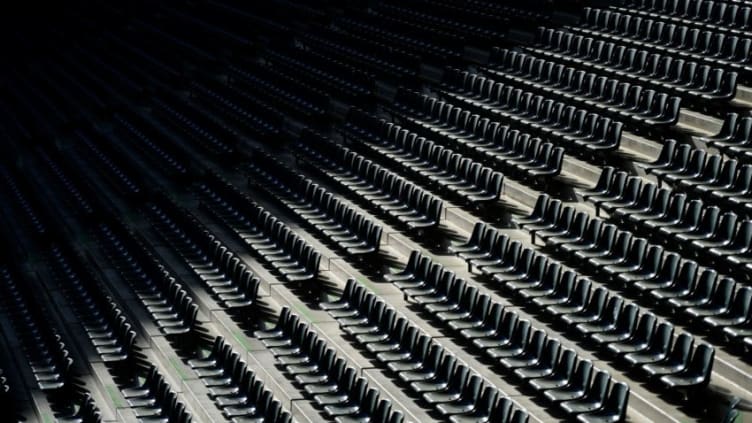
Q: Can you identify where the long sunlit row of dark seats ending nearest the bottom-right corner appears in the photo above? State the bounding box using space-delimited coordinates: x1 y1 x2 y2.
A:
450 222 714 390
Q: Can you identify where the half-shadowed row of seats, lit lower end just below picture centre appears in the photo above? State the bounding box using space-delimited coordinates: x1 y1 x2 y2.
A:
249 152 383 256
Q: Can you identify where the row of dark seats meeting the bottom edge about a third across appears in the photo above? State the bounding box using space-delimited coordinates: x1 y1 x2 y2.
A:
188 336 292 423
